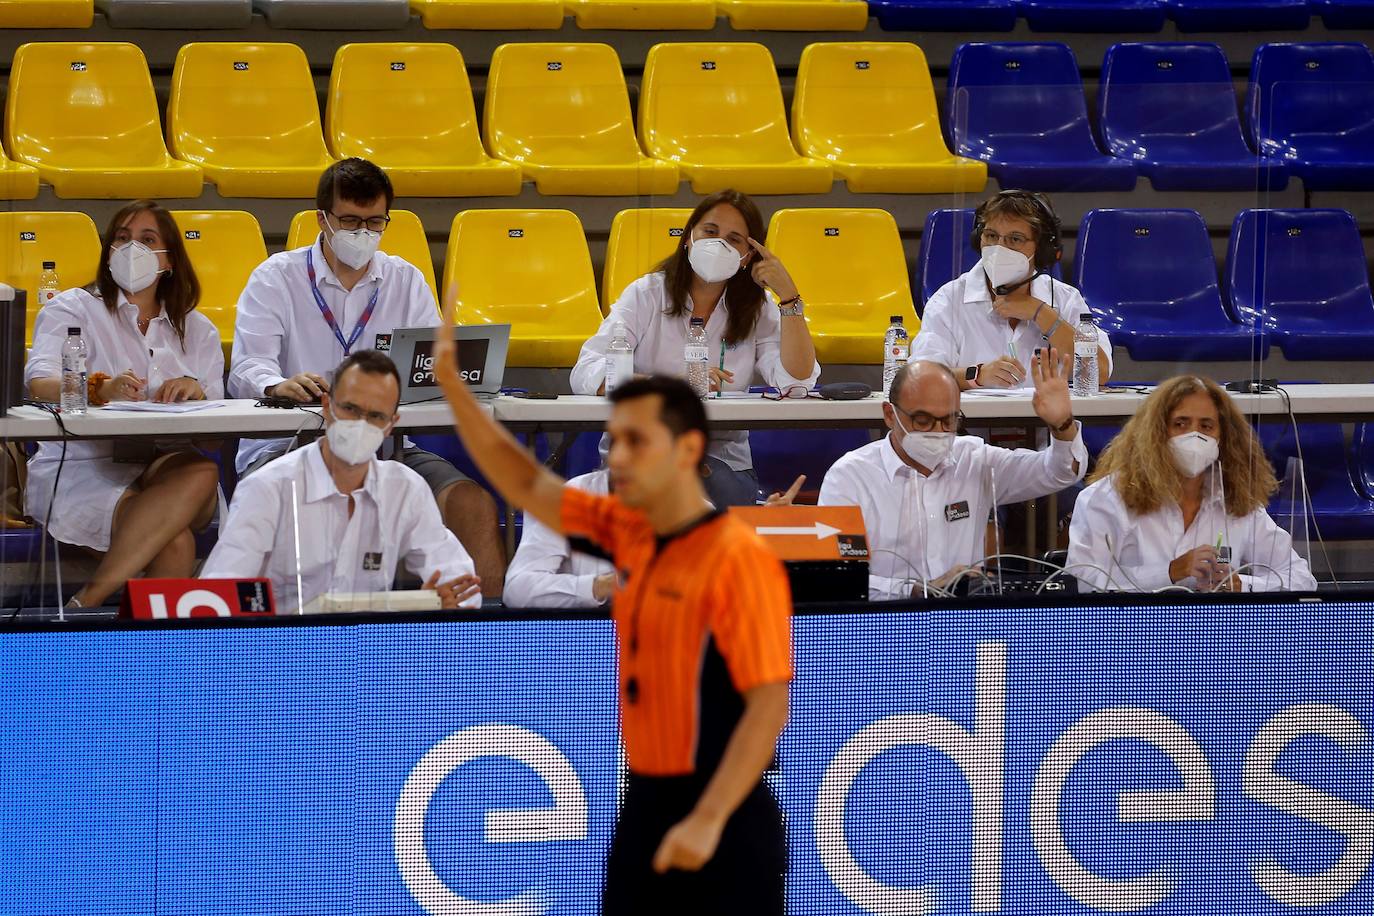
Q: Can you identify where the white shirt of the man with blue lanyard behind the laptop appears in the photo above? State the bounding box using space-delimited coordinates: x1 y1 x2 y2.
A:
229 236 440 471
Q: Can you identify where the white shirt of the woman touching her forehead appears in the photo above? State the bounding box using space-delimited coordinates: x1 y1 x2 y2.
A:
572 271 820 471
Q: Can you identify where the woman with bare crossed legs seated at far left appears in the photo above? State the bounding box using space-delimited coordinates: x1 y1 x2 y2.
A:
25 201 224 607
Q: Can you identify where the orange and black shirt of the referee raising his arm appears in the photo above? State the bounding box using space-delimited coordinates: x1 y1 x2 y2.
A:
562 486 791 776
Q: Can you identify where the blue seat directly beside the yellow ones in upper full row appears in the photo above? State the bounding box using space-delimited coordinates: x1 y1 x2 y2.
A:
948 43 1135 191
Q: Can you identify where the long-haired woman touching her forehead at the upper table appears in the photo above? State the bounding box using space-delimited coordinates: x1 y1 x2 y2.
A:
572 190 820 508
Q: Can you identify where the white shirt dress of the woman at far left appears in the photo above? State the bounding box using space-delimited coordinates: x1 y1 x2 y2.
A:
23 290 224 551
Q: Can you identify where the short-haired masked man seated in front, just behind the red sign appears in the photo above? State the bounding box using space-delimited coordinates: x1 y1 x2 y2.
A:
201 350 481 610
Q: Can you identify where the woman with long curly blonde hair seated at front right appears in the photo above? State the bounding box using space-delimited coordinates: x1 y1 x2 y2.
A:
1068 375 1316 592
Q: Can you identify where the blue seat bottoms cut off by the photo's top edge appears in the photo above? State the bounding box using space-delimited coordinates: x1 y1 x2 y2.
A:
868 0 1374 33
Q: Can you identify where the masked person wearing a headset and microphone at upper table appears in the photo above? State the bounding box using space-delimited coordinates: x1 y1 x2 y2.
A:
911 191 1112 390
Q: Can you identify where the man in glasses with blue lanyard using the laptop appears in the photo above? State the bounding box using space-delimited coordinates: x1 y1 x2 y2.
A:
228 158 506 597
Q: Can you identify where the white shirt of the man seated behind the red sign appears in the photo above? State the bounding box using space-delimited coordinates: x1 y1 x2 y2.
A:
201 441 482 612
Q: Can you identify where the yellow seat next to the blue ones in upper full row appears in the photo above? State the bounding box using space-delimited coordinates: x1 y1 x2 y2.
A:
791 41 988 194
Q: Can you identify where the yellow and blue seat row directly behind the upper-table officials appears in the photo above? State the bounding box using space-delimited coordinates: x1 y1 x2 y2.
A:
0 207 1374 367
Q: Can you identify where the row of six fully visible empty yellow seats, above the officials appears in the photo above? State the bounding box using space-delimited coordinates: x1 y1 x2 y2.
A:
0 43 987 198
